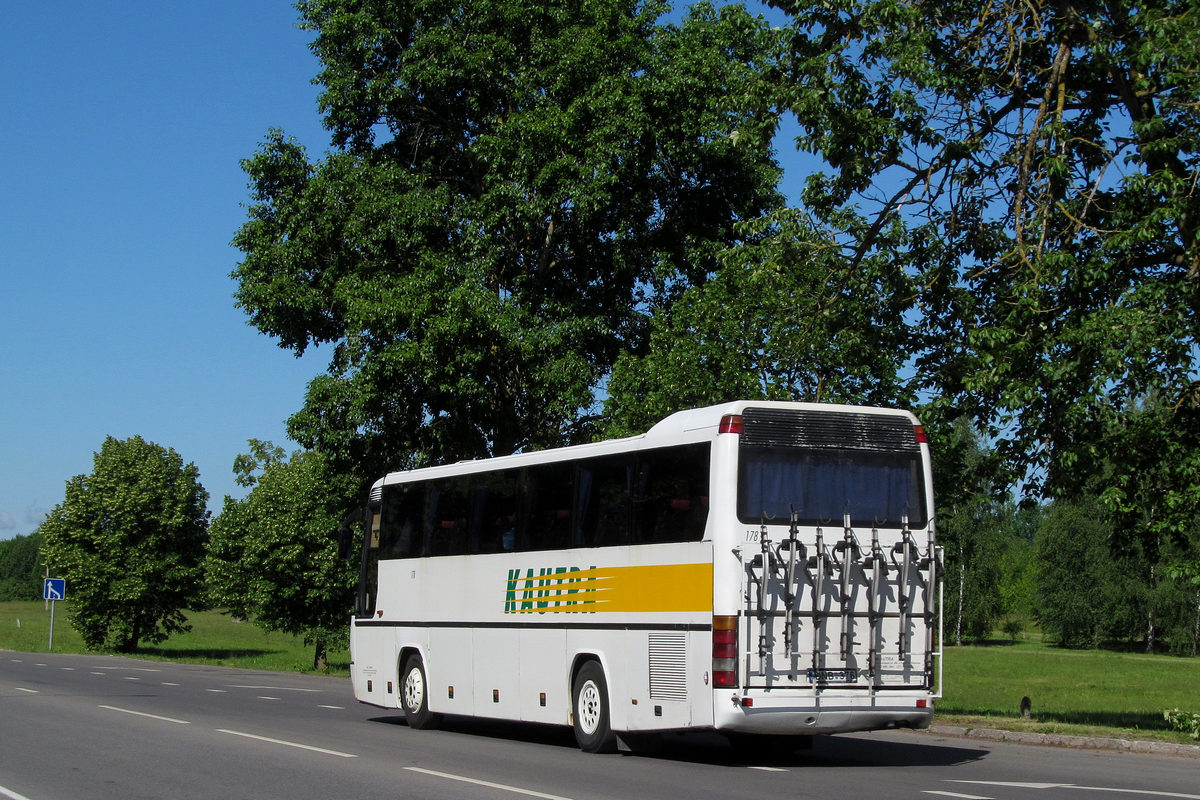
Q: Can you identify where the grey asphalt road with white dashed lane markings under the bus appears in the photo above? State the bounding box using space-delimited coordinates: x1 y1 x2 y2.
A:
0 651 1200 800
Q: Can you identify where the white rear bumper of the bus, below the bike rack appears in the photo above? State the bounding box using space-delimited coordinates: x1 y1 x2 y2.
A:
713 690 934 735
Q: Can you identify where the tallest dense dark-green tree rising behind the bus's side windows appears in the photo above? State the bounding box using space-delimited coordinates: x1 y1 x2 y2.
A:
234 0 779 473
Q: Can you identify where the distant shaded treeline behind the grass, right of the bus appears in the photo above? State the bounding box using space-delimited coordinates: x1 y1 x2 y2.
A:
938 497 1200 656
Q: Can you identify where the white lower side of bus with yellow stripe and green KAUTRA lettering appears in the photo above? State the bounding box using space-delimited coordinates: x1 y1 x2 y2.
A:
369 542 713 730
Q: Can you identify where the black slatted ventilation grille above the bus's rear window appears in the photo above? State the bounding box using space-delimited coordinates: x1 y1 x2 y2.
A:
742 408 920 452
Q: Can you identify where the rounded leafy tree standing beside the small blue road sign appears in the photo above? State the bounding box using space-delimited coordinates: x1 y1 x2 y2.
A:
38 437 209 652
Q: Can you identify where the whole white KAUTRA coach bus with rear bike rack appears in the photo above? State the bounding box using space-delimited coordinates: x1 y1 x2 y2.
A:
350 402 941 752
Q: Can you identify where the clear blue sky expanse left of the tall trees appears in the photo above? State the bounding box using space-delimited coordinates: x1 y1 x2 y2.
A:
0 0 328 539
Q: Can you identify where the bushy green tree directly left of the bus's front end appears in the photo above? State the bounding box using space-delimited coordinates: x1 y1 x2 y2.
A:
204 440 356 669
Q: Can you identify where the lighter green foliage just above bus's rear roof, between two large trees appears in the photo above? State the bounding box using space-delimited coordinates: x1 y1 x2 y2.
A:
605 210 913 434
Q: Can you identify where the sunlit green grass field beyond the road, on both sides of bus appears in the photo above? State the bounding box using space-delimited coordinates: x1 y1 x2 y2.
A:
0 602 1200 744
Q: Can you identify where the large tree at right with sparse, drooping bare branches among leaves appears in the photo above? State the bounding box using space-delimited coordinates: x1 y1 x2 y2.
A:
773 0 1200 519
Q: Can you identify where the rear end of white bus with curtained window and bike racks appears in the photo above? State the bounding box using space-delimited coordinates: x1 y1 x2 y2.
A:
712 403 941 735
